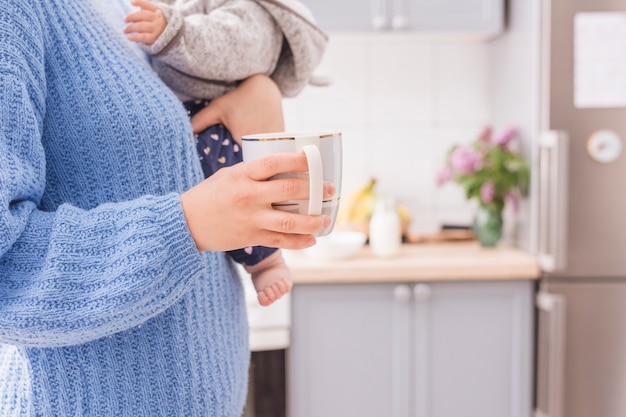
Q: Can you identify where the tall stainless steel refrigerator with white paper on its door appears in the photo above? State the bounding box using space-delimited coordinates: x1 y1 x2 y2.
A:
535 0 626 417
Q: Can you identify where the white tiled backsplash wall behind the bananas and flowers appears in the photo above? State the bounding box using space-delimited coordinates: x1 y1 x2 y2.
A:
284 34 490 233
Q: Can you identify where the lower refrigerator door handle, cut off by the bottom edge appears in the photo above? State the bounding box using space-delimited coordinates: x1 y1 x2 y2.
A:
534 291 566 417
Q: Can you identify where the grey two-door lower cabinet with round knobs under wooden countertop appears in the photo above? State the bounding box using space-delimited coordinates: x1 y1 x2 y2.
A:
287 281 534 417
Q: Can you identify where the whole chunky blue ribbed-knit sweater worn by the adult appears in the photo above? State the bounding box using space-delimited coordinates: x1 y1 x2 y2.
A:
0 0 249 417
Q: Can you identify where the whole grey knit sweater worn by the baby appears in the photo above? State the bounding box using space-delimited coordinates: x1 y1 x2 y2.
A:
142 0 328 99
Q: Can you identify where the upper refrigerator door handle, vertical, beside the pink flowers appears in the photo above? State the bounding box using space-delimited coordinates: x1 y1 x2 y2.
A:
539 130 569 272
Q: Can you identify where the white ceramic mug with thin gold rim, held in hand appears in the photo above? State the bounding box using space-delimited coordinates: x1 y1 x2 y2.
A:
241 132 342 236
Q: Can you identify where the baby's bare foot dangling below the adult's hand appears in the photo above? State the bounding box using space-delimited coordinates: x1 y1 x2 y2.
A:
244 250 293 306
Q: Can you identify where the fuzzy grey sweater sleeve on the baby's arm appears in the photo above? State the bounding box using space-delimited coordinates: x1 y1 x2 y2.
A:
142 0 283 82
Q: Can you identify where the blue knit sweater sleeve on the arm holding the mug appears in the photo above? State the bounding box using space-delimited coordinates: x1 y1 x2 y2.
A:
0 1 205 347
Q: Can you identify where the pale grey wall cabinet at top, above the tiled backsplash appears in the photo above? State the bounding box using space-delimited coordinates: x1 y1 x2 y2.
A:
303 0 504 37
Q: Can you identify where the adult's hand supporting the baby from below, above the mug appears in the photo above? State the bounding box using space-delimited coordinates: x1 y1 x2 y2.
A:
191 74 285 144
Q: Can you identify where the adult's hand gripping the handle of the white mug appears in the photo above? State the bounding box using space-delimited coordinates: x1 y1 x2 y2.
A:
180 153 335 251
